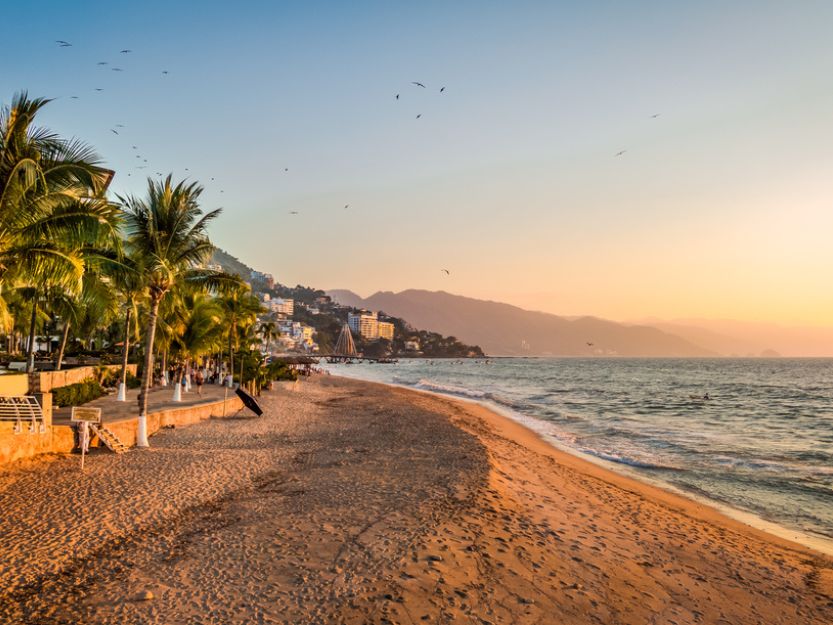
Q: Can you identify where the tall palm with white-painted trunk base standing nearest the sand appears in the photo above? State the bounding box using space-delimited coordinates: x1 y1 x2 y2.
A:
119 175 240 447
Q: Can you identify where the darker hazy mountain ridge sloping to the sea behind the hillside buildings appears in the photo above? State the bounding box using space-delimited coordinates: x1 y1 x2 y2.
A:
328 289 718 357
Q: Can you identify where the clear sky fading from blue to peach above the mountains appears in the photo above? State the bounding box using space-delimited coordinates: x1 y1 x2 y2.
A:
0 1 833 325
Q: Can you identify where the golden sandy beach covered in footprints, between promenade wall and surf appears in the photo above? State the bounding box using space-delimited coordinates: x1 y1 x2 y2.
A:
0 377 833 625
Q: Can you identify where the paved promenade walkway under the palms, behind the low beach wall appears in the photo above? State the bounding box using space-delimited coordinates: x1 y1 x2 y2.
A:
52 384 236 425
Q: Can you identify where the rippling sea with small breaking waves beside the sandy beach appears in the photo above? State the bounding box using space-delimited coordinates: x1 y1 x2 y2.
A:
327 358 833 539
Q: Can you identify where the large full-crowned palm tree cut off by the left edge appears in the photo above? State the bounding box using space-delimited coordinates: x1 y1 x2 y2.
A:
0 92 118 370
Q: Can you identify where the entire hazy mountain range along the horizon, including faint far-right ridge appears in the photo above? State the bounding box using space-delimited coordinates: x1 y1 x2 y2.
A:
328 289 833 357
